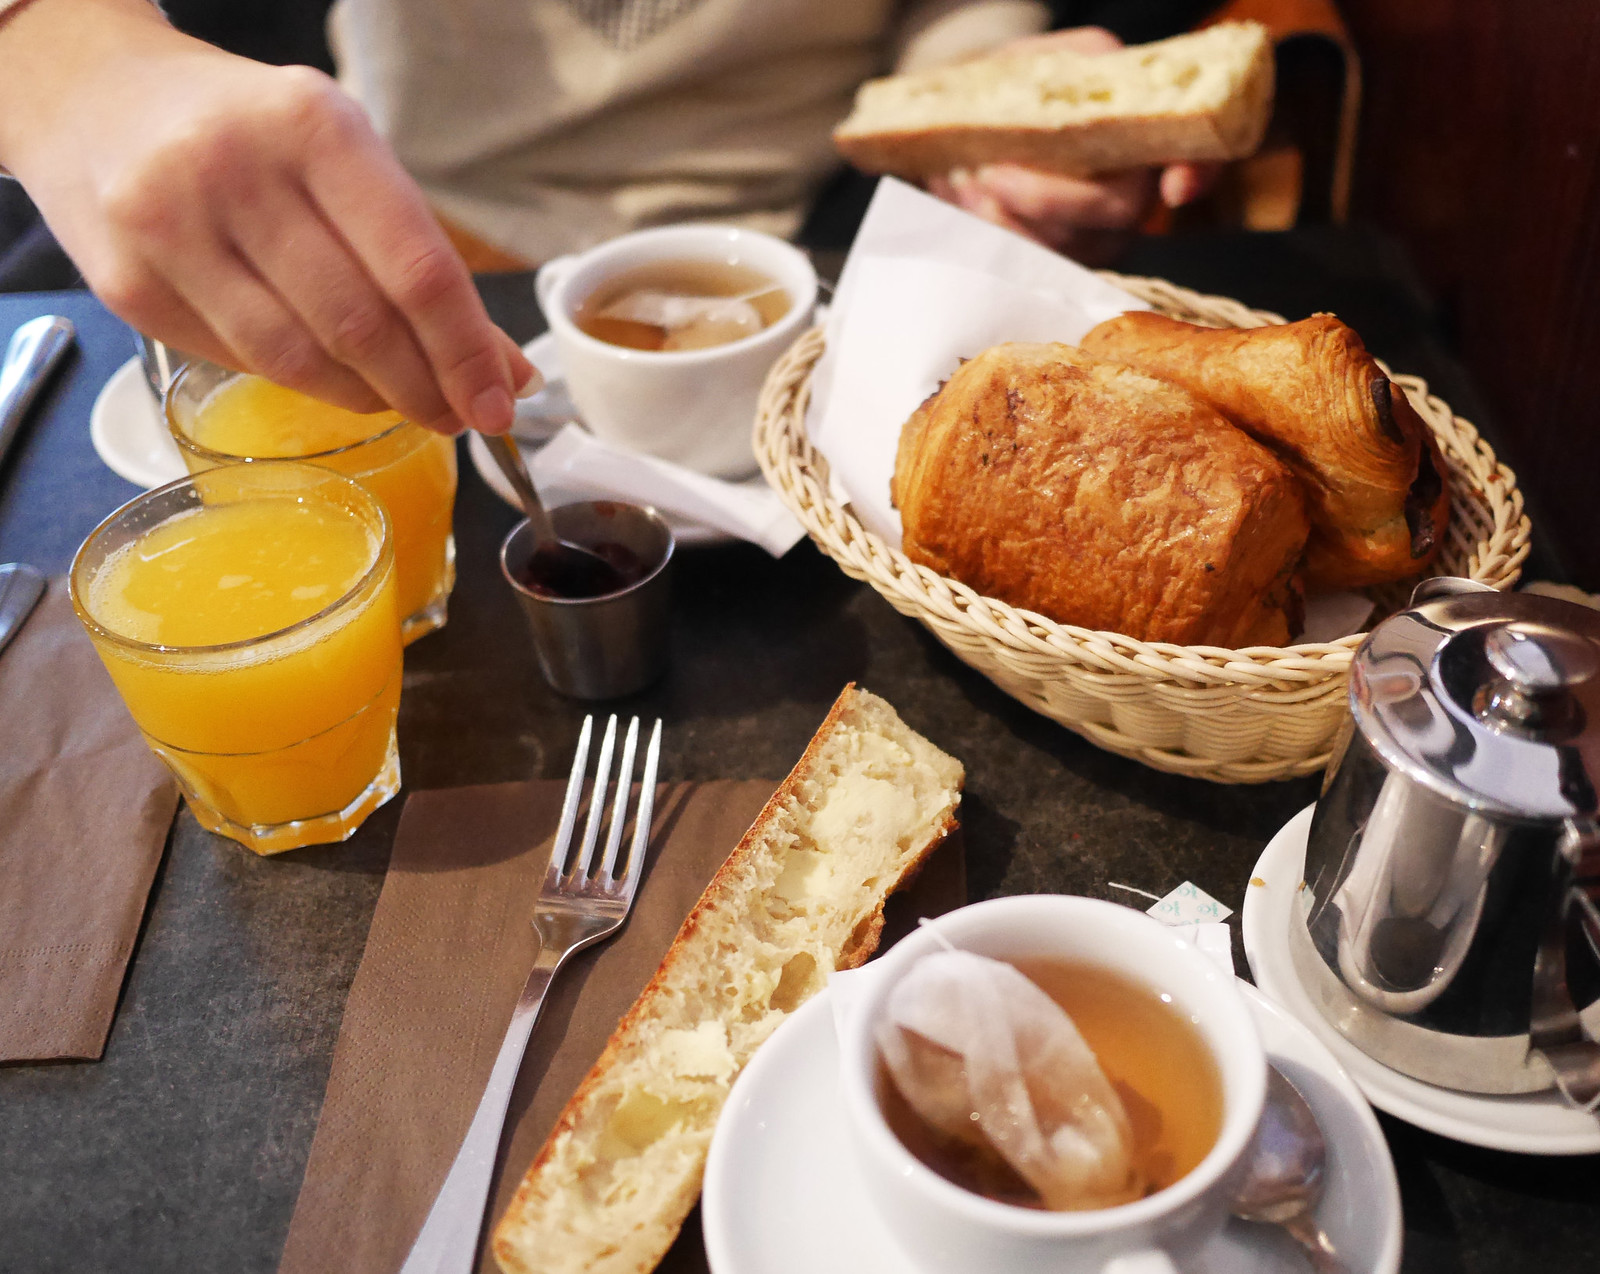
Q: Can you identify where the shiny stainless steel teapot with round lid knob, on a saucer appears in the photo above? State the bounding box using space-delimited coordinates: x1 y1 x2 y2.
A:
1290 579 1600 1109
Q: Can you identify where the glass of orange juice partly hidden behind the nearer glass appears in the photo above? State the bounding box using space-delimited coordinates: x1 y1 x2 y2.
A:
166 360 456 642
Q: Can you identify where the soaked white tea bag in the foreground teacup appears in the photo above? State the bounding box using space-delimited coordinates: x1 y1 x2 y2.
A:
875 951 1144 1212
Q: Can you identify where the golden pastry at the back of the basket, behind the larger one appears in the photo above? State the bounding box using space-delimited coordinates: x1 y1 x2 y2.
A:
1082 312 1450 589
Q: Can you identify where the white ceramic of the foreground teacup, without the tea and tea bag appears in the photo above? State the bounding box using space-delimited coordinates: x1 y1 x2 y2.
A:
840 895 1267 1274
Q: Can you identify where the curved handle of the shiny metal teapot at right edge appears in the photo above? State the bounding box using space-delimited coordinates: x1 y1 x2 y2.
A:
1528 819 1600 1111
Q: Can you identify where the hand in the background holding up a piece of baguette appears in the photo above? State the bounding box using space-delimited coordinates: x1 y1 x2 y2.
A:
928 27 1221 264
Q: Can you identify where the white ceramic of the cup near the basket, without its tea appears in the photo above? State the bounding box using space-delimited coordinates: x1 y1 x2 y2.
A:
534 226 816 479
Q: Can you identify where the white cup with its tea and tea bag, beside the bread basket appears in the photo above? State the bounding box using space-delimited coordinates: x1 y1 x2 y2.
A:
534 226 816 479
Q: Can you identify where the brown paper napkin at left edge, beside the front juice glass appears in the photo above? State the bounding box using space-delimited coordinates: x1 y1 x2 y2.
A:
0 579 178 1061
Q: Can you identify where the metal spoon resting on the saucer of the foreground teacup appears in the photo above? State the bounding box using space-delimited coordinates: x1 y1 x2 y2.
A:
1232 1063 1349 1274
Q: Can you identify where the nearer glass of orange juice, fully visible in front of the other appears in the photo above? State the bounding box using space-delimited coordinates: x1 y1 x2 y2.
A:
69 463 400 853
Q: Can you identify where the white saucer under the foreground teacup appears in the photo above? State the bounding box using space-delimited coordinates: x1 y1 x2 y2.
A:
701 983 1400 1274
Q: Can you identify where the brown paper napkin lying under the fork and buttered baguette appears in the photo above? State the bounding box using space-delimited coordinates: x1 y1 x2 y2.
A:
278 779 965 1274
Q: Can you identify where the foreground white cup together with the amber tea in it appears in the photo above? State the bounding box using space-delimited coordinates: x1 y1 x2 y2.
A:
840 895 1266 1274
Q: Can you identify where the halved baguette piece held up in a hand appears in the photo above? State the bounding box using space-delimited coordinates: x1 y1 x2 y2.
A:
834 22 1272 181
